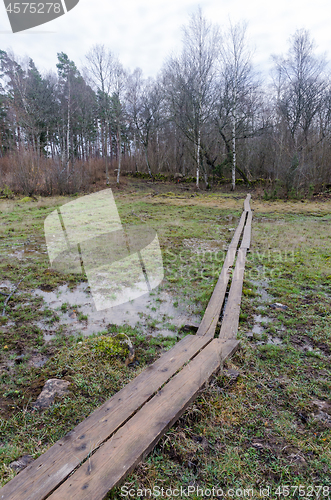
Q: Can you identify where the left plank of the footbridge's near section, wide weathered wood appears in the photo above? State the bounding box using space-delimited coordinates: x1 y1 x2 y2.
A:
0 335 210 500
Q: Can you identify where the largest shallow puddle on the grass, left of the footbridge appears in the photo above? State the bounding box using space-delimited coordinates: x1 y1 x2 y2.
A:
34 283 201 342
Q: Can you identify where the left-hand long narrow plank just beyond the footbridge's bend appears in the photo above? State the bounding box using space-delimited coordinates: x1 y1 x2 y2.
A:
197 212 246 337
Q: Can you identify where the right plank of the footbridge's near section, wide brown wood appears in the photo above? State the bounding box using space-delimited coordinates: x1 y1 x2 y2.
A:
49 339 239 500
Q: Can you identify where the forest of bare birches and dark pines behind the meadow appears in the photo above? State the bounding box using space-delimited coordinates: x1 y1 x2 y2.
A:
0 10 331 196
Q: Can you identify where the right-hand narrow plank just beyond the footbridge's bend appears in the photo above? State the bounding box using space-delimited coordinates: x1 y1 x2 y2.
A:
219 248 247 339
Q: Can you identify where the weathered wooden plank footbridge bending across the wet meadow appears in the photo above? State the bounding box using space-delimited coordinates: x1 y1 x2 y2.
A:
0 195 252 500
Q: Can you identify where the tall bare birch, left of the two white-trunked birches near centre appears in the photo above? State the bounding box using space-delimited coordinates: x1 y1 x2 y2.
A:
164 8 220 187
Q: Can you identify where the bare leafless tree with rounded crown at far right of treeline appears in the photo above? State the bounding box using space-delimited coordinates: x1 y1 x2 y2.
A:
273 29 329 187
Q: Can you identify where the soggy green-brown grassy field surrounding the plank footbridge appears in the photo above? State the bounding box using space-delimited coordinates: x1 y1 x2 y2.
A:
0 182 331 499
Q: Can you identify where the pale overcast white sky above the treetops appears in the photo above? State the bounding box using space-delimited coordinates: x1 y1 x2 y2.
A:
0 0 331 76
